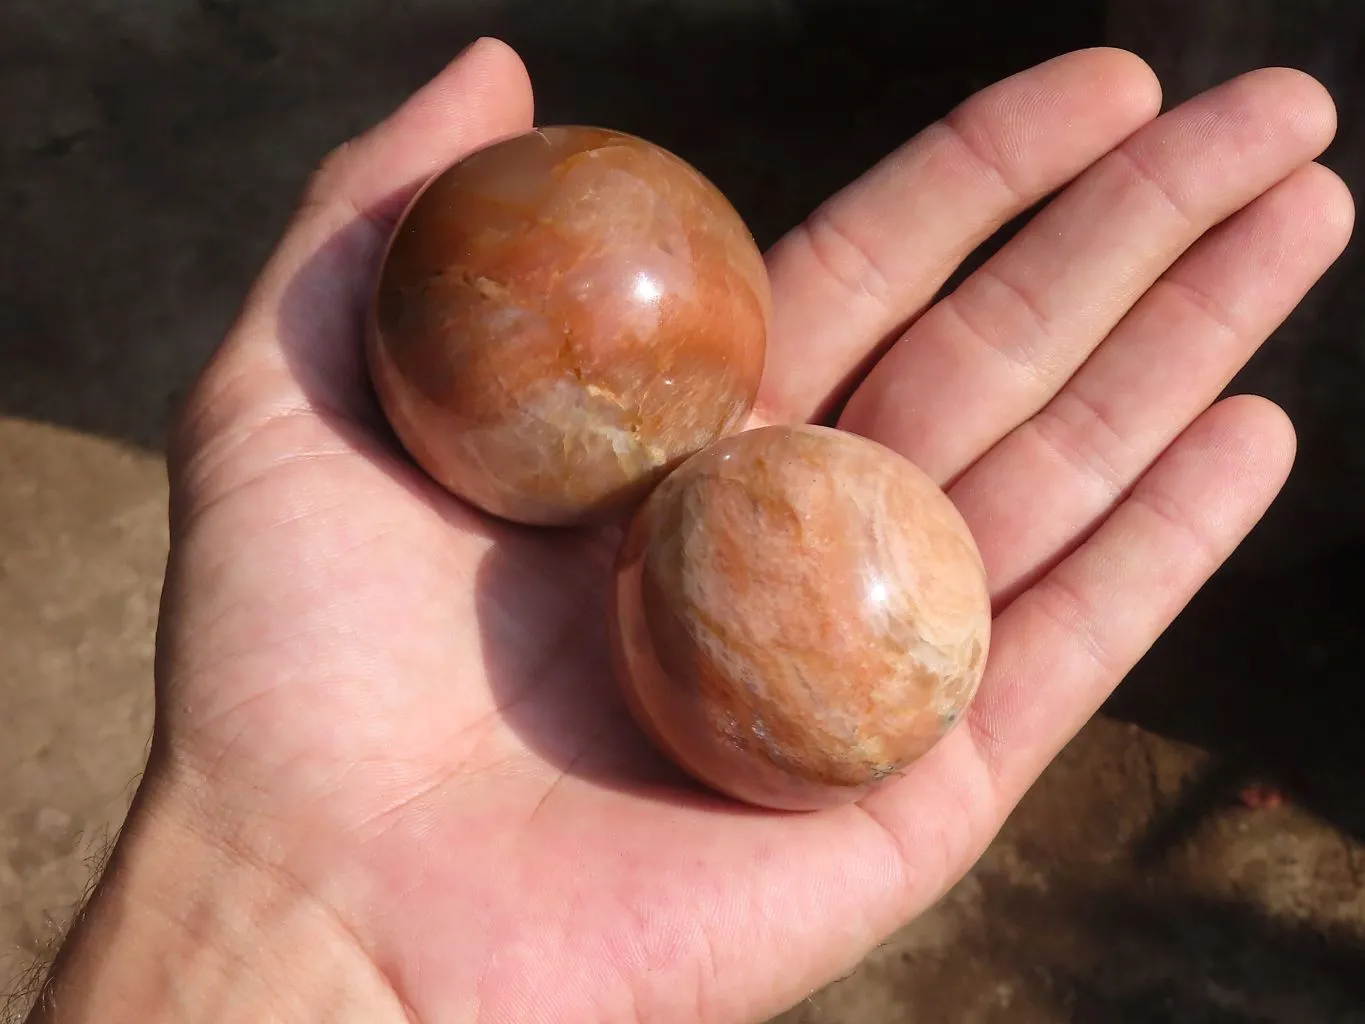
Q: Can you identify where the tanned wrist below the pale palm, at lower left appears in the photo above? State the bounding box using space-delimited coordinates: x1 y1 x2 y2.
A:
29 764 412 1024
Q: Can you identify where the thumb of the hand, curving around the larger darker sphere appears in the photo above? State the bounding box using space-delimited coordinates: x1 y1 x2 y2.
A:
169 38 532 502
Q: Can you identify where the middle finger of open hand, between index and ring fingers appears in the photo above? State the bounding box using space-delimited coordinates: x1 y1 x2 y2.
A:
841 68 1336 482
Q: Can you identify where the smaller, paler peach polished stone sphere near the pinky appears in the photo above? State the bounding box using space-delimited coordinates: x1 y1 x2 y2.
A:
613 426 991 810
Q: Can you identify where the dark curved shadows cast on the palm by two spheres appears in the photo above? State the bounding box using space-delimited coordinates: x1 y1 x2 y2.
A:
268 190 791 816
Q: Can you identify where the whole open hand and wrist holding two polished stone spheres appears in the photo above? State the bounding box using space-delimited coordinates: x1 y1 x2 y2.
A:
21 41 1353 1024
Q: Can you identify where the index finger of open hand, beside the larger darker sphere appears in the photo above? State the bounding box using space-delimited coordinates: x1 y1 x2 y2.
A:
759 49 1160 422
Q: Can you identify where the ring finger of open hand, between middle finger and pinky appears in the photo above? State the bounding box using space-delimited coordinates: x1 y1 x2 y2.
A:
951 164 1354 603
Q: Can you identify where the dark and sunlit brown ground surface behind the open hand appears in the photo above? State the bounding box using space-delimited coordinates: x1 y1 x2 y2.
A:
0 0 1365 1024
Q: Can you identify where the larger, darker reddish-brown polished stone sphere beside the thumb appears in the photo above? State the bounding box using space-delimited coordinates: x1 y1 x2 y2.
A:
369 127 771 526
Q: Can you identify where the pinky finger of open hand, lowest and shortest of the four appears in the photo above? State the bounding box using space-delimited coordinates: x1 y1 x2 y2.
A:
968 396 1295 808
